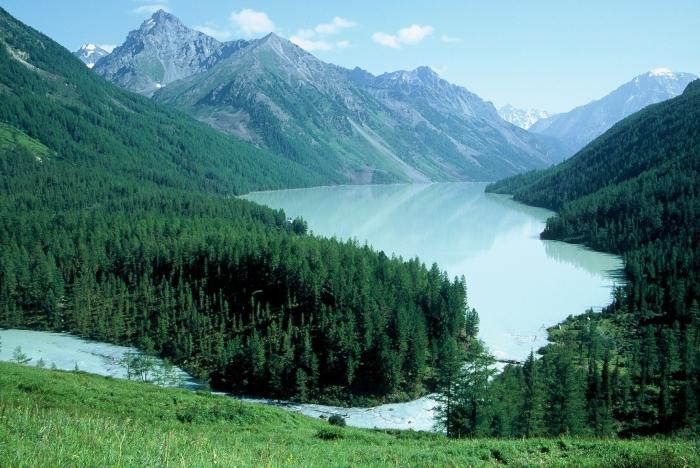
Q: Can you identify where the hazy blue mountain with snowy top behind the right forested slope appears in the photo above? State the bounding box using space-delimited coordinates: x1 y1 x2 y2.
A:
530 68 697 154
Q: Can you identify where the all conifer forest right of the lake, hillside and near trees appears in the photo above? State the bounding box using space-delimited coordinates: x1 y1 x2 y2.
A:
487 81 700 435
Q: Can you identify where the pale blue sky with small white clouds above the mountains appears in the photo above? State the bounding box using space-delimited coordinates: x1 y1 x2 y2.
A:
0 0 700 112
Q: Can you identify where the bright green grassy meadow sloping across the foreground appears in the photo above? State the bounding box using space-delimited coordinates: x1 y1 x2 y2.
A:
0 363 700 467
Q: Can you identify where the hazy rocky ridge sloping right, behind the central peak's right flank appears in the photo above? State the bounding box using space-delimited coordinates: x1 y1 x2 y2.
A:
344 67 561 178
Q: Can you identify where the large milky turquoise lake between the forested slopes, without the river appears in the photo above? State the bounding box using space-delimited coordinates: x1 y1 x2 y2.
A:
244 183 622 360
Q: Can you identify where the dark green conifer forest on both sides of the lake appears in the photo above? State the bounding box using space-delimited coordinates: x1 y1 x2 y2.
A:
0 0 700 450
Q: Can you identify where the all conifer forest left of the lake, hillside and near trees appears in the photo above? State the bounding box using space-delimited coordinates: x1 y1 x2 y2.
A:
0 9 466 401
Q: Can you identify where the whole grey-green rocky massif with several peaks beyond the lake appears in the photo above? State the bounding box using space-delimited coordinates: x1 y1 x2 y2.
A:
95 11 560 183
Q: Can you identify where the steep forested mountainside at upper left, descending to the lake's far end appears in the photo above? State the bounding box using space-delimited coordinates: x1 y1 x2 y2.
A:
0 9 325 193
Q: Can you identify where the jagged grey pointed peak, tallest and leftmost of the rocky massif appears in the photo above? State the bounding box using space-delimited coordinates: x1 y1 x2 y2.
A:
95 10 246 96
